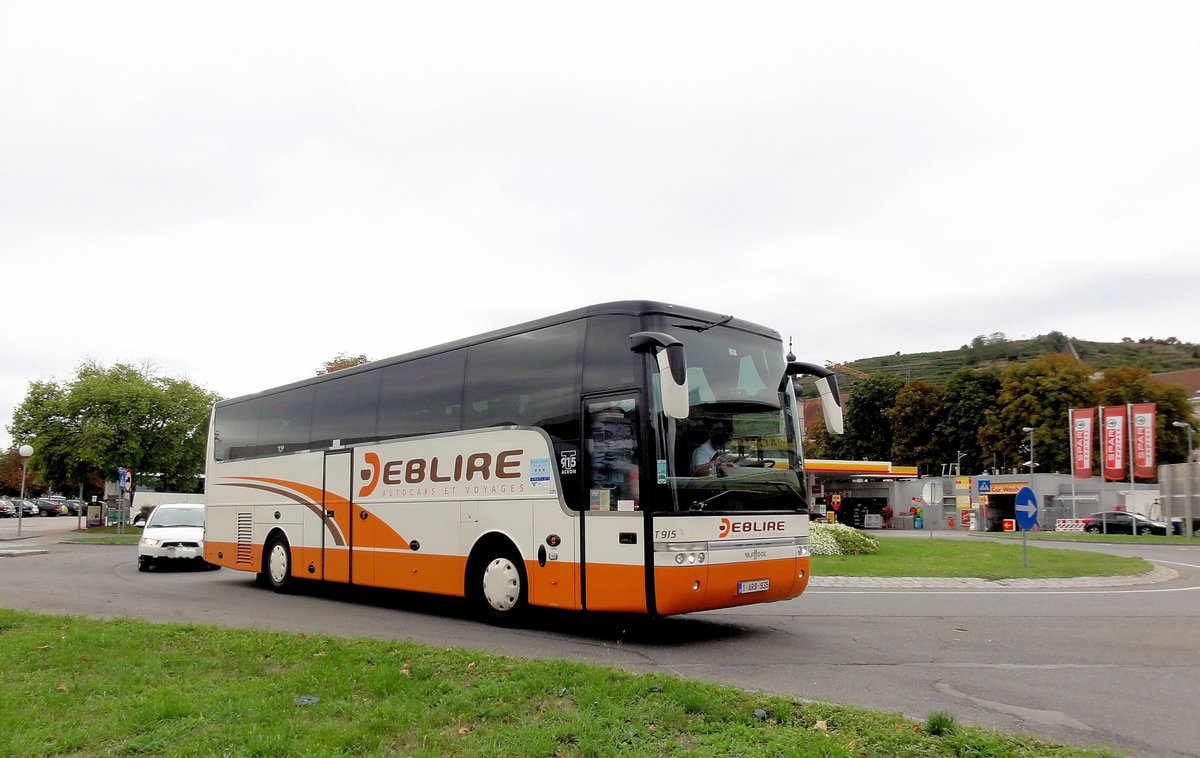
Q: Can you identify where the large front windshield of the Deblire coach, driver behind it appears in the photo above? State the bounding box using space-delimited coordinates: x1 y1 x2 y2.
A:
655 321 806 512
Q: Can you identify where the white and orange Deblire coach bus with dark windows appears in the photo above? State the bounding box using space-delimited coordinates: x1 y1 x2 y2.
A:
204 301 841 621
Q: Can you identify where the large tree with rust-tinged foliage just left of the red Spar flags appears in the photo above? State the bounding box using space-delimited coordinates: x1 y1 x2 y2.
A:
979 354 1096 474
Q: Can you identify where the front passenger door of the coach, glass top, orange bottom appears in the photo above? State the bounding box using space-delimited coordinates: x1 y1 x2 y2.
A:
581 395 647 613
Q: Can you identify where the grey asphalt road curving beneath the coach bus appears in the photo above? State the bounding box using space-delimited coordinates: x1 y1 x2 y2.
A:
0 527 1200 758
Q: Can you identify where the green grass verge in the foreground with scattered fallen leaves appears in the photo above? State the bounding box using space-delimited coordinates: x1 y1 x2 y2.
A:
0 609 1114 758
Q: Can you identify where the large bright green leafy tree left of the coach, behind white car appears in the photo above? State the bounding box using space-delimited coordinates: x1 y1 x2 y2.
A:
8 361 217 501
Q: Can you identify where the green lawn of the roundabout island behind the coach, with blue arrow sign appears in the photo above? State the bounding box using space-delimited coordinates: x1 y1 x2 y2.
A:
812 537 1153 579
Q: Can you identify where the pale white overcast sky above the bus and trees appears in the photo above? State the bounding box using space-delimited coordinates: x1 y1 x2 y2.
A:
0 0 1200 446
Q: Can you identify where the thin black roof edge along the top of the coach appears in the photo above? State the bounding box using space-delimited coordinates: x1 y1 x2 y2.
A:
216 300 779 405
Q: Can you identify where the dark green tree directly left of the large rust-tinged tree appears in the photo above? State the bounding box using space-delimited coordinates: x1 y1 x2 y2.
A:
936 367 1000 473
